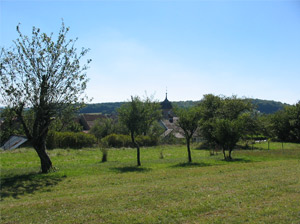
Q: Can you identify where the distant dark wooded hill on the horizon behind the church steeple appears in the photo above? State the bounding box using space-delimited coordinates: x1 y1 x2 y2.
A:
79 99 288 114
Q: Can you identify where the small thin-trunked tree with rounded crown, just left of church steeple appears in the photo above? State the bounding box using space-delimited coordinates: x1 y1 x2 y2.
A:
118 96 161 166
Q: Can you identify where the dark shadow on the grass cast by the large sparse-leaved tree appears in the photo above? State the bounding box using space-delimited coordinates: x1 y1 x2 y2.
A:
0 173 66 201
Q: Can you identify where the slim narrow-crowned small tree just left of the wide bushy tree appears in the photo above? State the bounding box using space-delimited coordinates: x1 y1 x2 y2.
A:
175 106 200 163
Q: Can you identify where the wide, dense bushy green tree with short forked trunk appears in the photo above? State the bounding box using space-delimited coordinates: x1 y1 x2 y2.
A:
200 95 254 159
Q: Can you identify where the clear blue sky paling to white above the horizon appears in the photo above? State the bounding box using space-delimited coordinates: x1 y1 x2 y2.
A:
0 0 300 104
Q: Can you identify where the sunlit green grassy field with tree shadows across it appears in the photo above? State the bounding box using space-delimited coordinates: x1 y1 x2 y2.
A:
0 143 300 223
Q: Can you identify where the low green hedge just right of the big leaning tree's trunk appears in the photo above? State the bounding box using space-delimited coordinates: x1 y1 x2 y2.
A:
46 132 96 149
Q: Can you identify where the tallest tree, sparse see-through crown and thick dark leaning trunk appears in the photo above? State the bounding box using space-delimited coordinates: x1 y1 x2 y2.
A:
0 22 91 173
